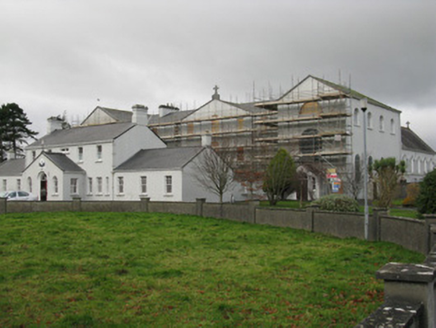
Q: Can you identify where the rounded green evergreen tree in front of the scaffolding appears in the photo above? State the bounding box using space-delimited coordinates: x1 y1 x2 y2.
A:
263 148 296 205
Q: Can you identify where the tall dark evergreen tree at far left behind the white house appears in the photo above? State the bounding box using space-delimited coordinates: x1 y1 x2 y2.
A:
0 103 38 161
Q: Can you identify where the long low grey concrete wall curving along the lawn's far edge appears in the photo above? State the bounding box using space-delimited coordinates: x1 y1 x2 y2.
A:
0 198 430 254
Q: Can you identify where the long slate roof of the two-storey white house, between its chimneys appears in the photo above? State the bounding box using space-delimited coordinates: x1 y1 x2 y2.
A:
27 123 135 149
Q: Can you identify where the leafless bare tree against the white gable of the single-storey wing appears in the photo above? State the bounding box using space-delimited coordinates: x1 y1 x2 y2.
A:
194 147 234 203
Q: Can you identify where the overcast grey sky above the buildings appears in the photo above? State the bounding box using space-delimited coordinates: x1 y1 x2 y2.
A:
0 0 436 149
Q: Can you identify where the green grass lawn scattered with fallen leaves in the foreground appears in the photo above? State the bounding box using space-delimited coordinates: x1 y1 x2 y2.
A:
0 213 423 327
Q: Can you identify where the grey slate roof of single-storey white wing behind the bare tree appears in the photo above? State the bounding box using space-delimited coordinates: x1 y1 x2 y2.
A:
115 147 204 171
